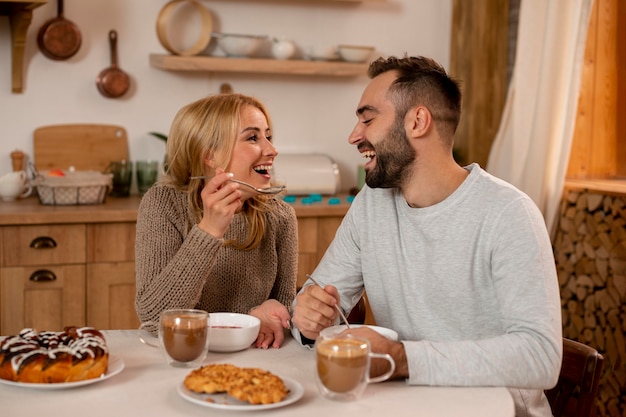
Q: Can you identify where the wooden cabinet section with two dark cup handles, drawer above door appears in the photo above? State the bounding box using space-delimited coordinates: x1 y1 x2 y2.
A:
0 225 86 334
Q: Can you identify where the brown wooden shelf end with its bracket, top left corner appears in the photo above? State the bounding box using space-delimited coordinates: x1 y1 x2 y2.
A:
0 0 48 93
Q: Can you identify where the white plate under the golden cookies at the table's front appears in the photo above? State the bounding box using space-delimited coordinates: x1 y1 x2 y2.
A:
178 376 304 411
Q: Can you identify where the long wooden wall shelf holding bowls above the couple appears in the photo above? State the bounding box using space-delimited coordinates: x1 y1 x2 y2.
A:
150 54 368 77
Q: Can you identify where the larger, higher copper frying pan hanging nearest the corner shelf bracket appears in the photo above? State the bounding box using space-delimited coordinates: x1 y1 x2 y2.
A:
37 0 82 61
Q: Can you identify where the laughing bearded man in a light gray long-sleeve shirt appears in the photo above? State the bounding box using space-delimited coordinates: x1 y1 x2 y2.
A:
292 56 563 416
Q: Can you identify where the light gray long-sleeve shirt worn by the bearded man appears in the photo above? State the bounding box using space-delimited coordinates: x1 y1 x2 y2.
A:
296 164 562 416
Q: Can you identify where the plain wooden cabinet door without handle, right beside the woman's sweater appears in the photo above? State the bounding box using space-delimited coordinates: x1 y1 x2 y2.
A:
87 262 139 329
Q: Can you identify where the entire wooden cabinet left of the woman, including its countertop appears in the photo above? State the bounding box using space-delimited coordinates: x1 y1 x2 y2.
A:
0 197 139 334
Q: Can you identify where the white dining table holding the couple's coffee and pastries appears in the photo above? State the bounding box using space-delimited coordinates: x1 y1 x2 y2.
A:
0 330 515 417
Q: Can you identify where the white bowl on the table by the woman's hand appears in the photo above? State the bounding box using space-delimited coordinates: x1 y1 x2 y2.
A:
209 313 261 352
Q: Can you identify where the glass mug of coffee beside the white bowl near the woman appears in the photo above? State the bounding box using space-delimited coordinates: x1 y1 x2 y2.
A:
139 309 210 367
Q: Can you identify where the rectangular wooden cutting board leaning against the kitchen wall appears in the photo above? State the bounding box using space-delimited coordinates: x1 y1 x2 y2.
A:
33 124 128 172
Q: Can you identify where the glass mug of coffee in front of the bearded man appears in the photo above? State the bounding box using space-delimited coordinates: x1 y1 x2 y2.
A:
315 334 396 401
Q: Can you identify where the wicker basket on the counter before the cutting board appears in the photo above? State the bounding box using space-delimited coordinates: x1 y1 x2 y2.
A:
33 171 113 206
